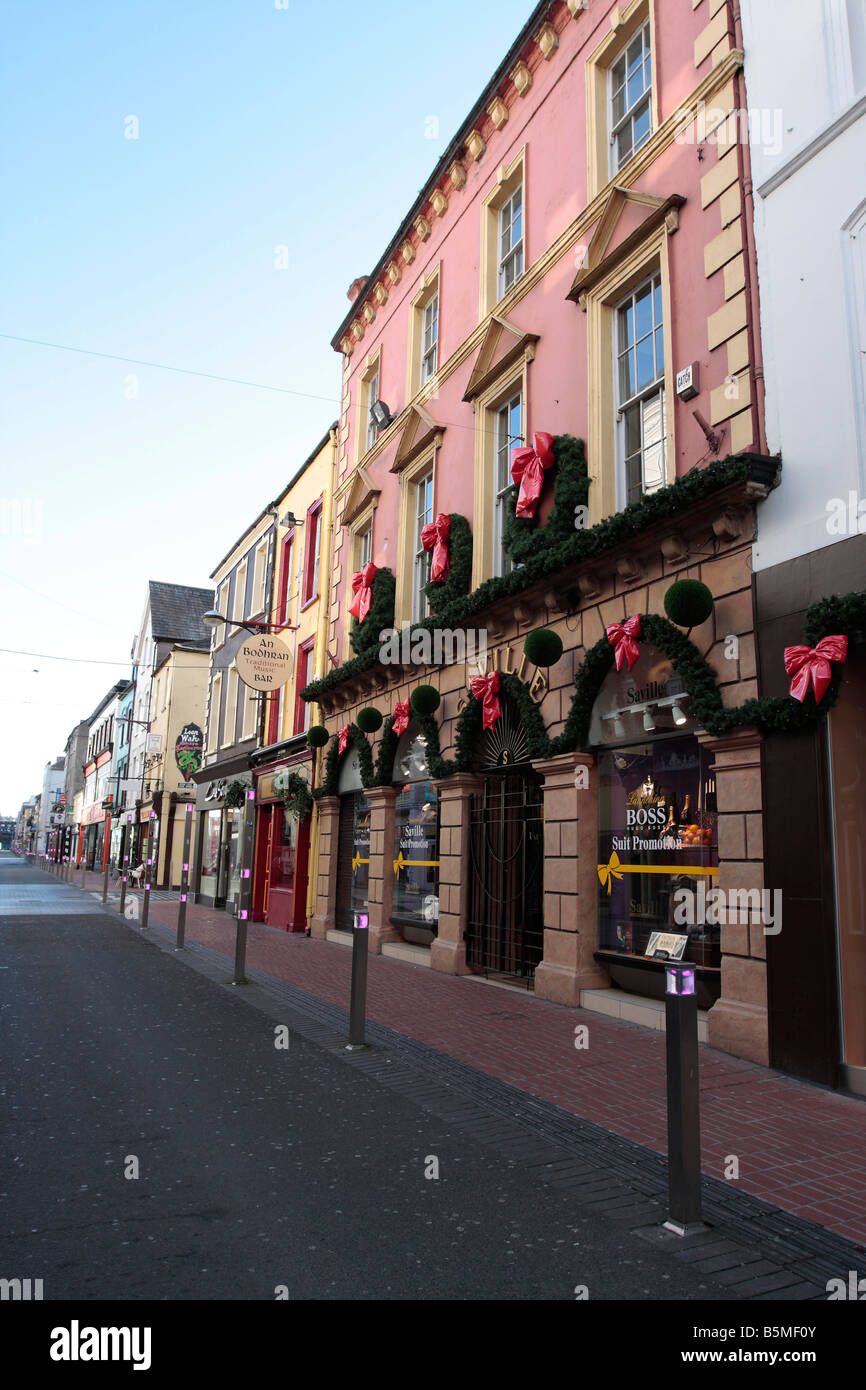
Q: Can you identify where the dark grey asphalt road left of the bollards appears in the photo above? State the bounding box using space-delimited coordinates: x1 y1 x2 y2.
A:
0 853 734 1301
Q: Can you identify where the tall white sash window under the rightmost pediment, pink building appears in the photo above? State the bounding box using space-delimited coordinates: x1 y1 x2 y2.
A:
613 270 667 510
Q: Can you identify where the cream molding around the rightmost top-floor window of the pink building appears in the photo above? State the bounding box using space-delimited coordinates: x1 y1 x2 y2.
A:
587 0 660 203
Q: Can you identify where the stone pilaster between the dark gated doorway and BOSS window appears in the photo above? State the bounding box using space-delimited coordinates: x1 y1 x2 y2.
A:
532 753 610 1005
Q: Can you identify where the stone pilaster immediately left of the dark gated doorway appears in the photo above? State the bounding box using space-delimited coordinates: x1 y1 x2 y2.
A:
430 773 484 974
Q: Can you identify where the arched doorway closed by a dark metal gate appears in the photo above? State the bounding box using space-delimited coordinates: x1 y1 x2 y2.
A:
466 694 544 986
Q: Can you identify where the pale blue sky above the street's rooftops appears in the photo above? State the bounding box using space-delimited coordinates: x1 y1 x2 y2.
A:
0 0 534 815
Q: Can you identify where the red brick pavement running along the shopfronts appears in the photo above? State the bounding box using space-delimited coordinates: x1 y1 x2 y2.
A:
52 874 866 1243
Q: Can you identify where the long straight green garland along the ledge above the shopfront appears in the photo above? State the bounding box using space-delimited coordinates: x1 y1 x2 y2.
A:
300 453 751 701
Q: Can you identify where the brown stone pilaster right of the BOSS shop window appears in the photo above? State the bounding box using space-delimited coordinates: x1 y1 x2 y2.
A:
698 728 770 1066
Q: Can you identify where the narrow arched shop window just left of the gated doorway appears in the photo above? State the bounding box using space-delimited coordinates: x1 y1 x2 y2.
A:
391 721 439 947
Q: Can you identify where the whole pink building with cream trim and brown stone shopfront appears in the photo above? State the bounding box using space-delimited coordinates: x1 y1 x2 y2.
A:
309 0 777 1062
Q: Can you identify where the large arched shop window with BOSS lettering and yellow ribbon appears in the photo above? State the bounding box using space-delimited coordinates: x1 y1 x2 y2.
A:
589 644 724 1009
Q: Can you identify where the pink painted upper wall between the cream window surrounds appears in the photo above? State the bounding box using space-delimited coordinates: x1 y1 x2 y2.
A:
329 0 748 660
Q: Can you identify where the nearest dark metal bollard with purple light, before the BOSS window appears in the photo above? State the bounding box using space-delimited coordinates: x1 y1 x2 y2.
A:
664 965 702 1236
